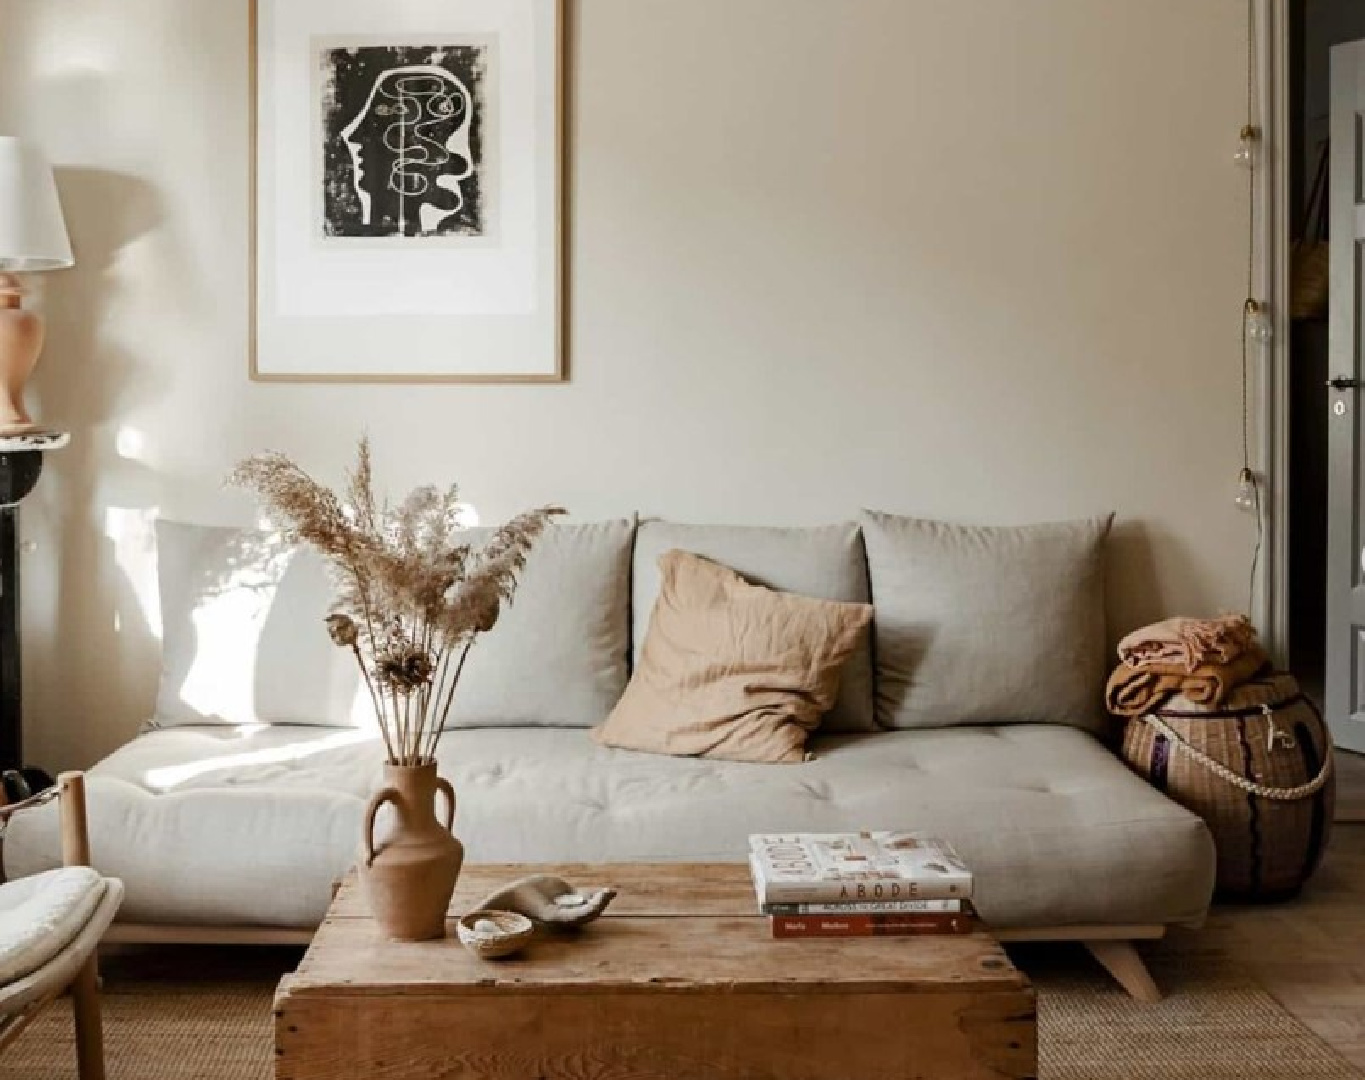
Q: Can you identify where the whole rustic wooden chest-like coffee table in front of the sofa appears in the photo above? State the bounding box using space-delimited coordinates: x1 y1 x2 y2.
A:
274 864 1037 1080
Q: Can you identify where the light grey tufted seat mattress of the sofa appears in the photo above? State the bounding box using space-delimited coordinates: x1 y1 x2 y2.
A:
5 724 1213 928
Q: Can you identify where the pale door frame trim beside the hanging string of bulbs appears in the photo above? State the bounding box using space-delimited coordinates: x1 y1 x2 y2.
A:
1250 0 1288 665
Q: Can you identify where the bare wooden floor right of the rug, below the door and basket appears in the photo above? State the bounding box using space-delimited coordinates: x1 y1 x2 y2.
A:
1173 819 1365 1070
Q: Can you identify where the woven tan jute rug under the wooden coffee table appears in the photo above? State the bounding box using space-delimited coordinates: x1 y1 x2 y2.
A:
0 948 1361 1080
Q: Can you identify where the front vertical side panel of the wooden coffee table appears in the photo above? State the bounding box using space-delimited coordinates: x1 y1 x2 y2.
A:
276 991 1037 1080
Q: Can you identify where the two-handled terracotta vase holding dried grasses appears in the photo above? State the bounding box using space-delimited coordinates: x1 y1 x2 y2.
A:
359 762 464 941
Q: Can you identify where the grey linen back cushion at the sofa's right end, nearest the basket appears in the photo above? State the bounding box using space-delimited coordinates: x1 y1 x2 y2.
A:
863 511 1112 730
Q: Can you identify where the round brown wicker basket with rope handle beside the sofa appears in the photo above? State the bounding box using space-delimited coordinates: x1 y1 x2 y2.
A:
1123 674 1335 900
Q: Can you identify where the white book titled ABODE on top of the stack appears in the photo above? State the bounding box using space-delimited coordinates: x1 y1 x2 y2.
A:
749 832 972 905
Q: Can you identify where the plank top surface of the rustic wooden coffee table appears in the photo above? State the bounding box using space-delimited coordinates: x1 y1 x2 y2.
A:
290 863 1029 998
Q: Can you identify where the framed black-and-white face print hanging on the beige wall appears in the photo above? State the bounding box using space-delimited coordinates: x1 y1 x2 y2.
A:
250 0 565 382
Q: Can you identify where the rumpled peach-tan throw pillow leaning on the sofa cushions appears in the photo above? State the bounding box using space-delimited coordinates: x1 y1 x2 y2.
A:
592 552 872 762
